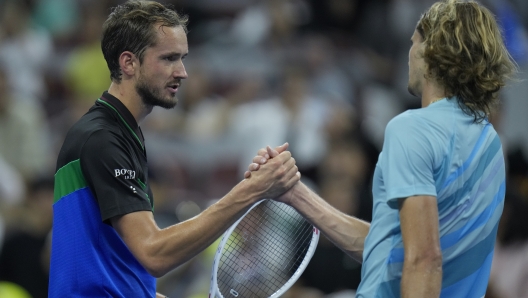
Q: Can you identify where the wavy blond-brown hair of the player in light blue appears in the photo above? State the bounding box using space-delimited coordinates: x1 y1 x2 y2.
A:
416 0 517 122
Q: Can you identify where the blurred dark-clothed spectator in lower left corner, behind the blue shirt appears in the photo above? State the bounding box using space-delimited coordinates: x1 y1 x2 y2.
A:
0 177 53 298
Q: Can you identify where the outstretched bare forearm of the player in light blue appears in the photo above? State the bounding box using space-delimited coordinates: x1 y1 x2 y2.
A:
291 182 370 263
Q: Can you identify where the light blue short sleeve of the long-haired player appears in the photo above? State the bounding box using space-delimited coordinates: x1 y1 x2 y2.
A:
380 113 437 208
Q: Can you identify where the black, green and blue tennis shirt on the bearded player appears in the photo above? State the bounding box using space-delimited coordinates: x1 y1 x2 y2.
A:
48 92 156 298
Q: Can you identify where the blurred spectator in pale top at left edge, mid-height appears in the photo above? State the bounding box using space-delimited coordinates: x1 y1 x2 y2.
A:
0 67 50 181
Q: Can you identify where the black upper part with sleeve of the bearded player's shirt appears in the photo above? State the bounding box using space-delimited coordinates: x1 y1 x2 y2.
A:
57 92 154 221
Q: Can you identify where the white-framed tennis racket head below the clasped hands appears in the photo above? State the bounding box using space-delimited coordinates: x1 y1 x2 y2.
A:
209 199 319 298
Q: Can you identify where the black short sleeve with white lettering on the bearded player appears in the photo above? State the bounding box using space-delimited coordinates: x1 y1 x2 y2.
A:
80 130 152 221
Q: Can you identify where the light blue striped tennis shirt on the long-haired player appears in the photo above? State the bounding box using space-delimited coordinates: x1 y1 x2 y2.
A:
356 98 505 298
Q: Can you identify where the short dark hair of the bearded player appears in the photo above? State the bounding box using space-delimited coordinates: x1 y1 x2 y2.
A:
101 0 188 82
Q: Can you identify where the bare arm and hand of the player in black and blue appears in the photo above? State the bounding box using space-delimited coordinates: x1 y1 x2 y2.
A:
111 152 300 277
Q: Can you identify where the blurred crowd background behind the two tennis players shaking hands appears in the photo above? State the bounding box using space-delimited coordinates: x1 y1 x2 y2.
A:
0 0 528 298
